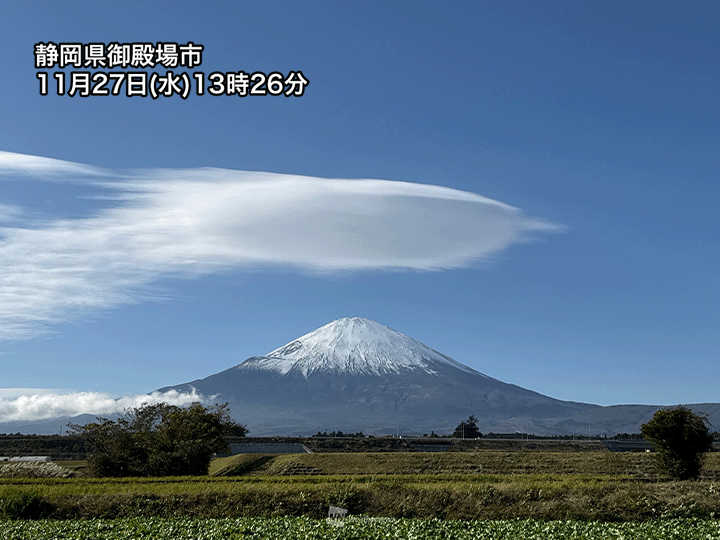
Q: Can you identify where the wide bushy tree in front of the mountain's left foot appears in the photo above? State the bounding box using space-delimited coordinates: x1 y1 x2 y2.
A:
69 403 247 477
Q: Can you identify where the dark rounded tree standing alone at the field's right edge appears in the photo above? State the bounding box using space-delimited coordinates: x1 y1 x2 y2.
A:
641 407 712 480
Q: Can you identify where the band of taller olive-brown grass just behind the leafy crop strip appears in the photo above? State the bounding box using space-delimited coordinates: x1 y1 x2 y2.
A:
0 477 720 520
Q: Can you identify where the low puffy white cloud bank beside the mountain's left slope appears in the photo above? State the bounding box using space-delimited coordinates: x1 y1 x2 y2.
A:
0 389 207 422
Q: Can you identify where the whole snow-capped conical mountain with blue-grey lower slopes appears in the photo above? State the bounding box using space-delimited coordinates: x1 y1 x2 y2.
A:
160 318 620 436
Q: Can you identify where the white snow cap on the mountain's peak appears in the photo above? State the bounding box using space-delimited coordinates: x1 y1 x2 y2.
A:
240 317 477 377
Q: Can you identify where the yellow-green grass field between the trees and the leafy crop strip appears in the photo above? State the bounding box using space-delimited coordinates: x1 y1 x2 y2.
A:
0 451 720 522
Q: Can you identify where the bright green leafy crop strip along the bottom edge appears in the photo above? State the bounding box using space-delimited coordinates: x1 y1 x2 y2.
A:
0 518 720 540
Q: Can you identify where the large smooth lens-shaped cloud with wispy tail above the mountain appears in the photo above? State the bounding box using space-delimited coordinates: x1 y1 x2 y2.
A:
0 152 560 339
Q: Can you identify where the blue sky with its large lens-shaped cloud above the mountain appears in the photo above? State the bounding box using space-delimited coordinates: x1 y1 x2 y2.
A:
0 0 720 419
